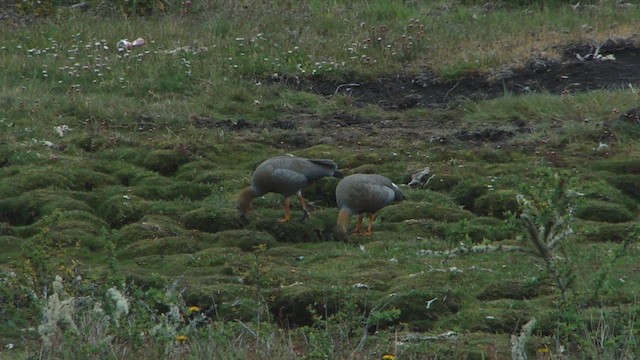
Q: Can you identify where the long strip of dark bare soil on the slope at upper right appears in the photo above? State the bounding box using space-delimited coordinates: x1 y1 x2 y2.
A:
280 39 640 109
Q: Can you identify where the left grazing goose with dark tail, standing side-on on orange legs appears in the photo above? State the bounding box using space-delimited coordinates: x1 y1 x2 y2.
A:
236 156 343 222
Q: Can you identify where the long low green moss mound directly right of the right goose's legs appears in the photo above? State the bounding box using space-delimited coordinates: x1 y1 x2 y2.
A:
378 201 473 222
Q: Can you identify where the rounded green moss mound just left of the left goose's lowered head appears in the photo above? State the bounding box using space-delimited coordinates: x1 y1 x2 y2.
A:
181 206 242 233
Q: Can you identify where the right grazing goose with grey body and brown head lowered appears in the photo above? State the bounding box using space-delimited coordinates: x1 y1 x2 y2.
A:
336 174 404 240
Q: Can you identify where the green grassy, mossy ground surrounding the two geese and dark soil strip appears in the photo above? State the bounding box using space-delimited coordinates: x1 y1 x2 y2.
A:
0 0 640 359
